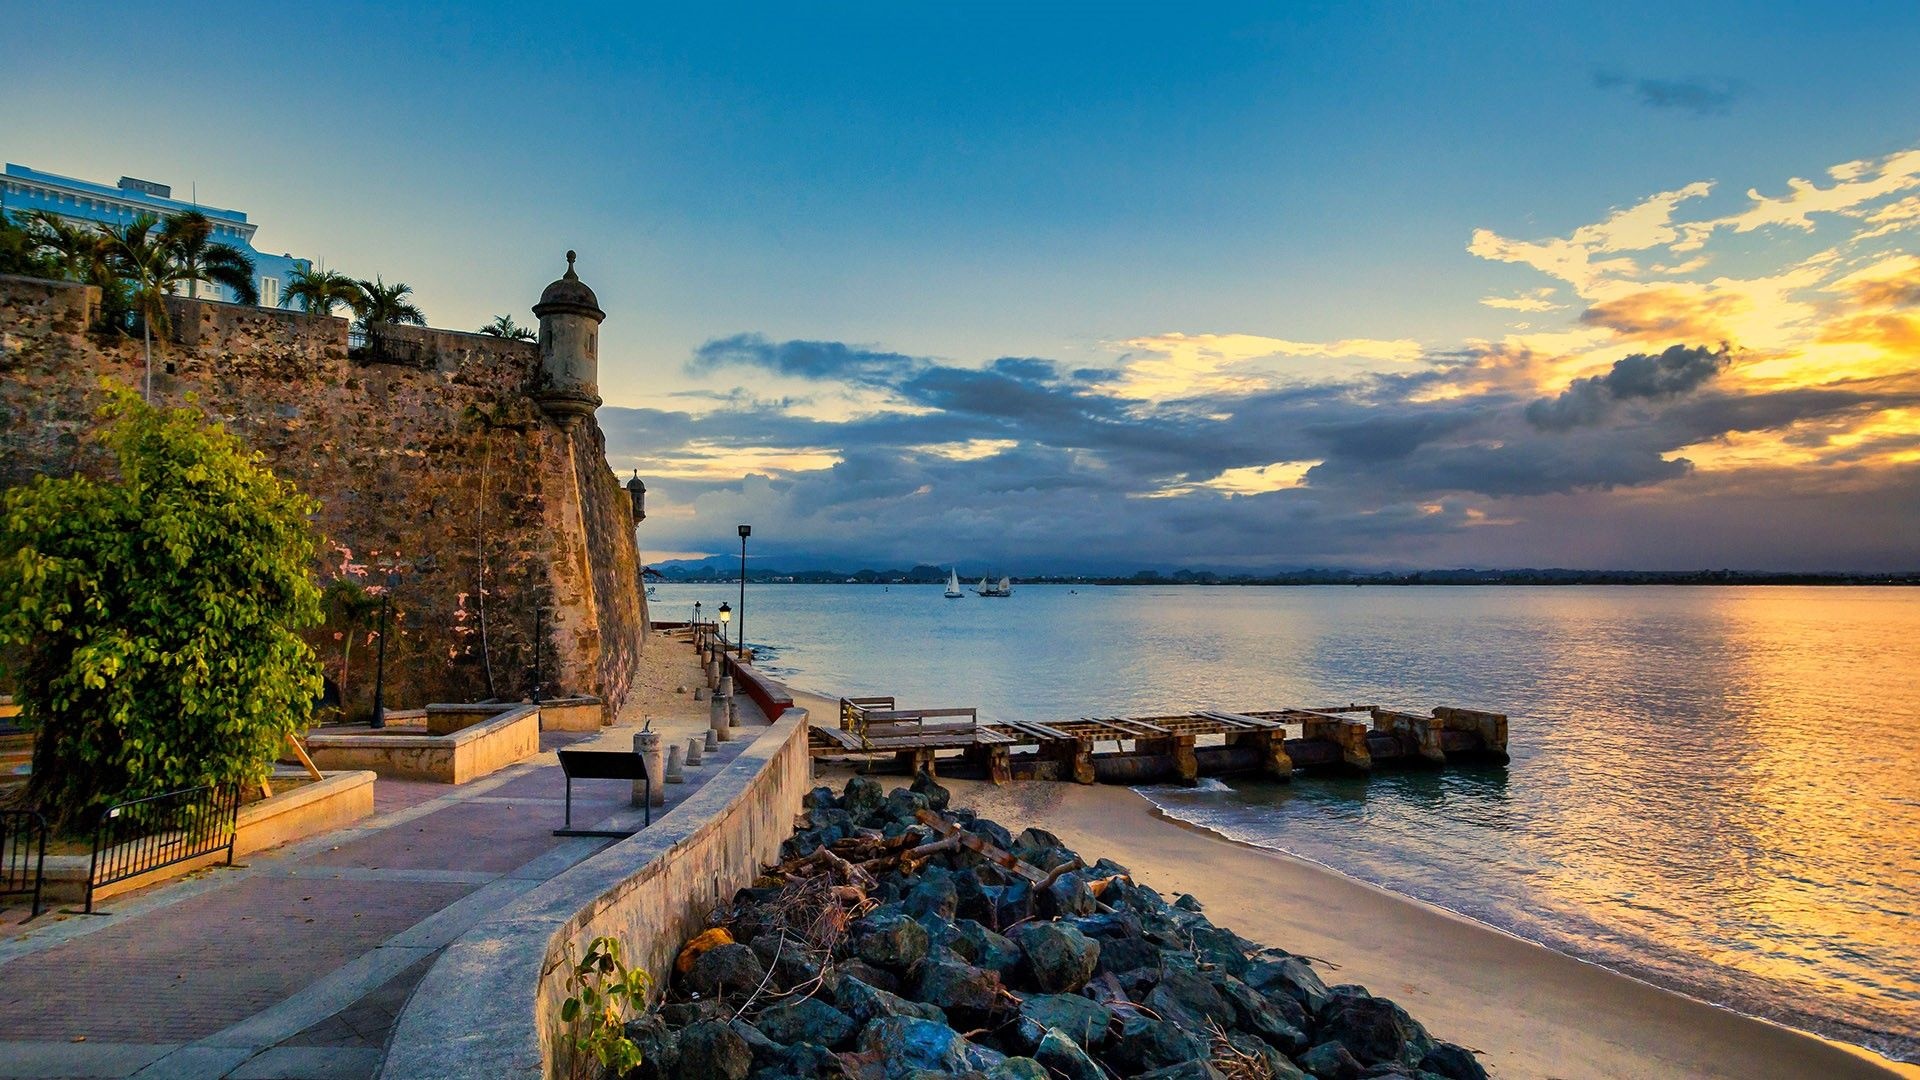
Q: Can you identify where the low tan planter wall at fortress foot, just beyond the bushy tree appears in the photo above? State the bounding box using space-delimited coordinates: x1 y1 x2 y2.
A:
307 705 540 784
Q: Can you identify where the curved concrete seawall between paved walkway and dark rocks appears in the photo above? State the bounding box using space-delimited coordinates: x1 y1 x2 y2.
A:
380 709 812 1080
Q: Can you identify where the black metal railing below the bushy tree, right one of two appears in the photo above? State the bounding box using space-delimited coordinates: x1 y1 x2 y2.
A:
86 784 240 915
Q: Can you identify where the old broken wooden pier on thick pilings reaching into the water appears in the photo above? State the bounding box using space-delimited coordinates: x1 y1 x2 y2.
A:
810 698 1507 784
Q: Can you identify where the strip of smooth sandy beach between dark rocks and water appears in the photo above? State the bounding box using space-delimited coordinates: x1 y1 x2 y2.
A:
801 680 1920 1080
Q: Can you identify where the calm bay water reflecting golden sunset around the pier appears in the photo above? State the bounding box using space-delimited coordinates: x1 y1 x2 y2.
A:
653 586 1920 1061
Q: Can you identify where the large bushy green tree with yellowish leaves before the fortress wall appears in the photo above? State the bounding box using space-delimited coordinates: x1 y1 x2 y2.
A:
0 390 321 830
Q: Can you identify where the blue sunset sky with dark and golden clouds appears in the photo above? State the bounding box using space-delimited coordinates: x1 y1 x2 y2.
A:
0 0 1920 577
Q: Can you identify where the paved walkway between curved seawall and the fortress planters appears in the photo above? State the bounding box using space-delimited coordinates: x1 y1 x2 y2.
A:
0 638 766 1080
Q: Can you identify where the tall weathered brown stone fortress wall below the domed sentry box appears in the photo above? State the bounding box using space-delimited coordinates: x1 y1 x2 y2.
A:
0 277 645 713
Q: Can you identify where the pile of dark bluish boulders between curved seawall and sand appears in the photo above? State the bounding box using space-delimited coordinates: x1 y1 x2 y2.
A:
628 774 1486 1080
